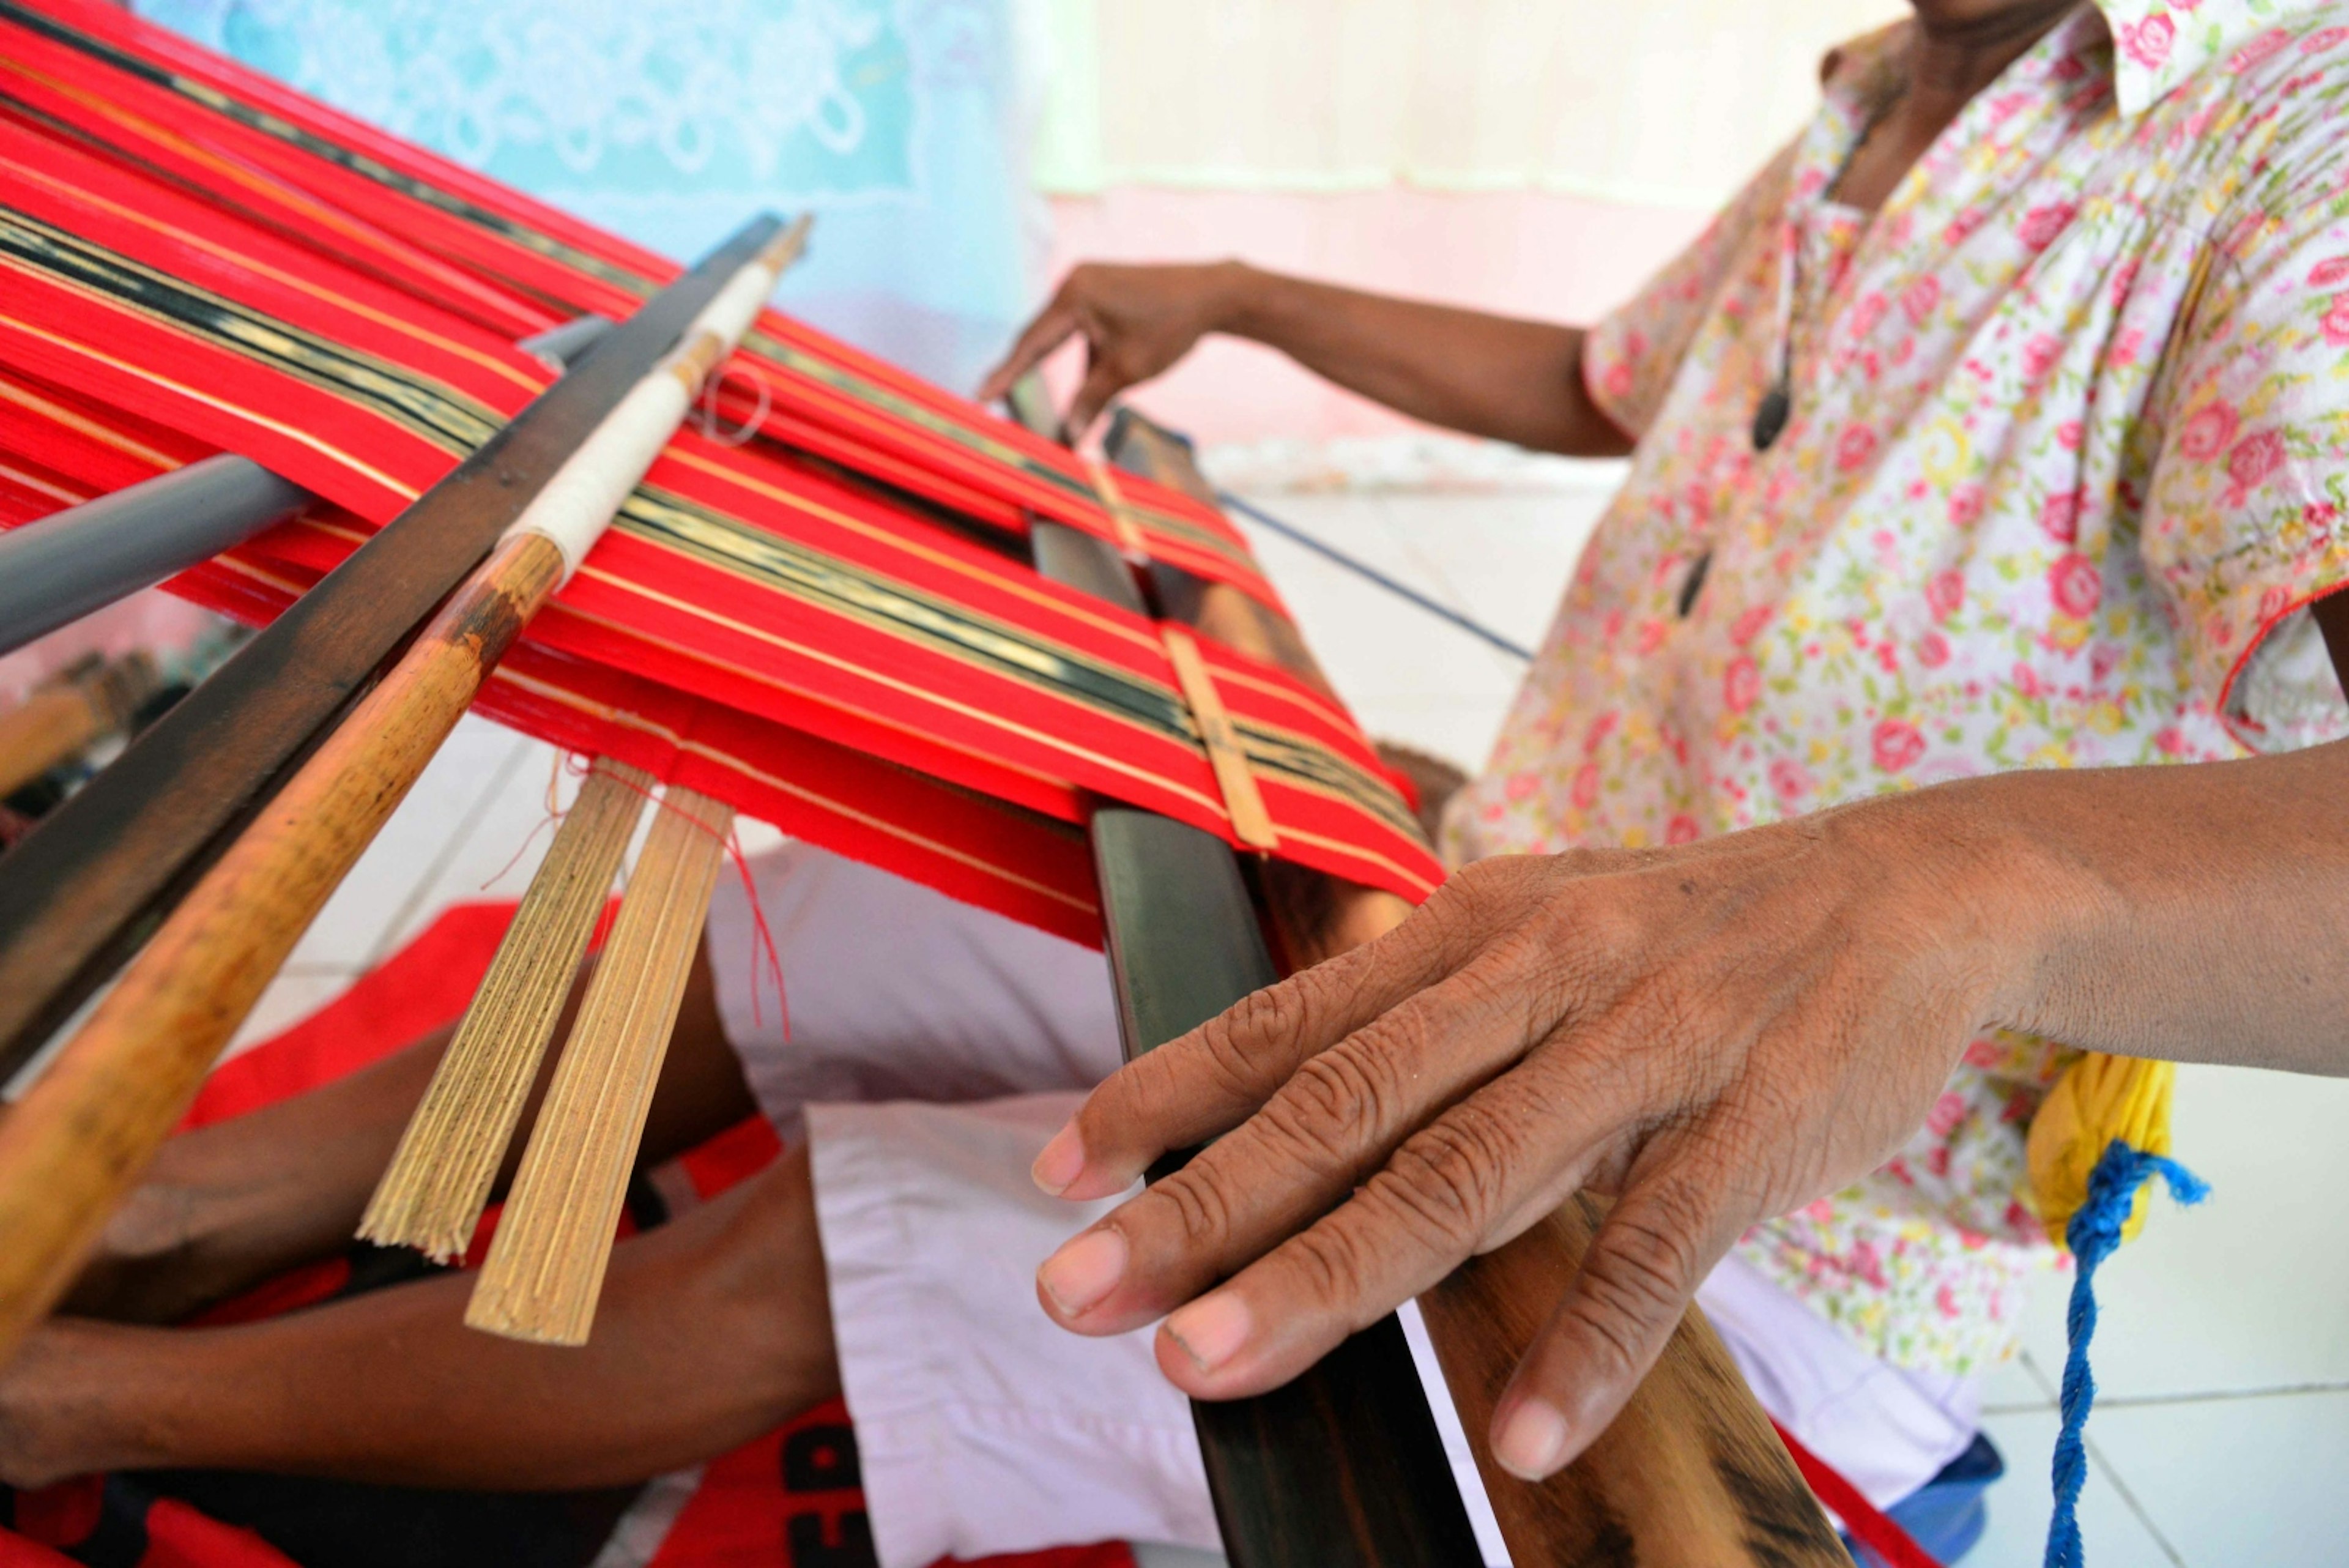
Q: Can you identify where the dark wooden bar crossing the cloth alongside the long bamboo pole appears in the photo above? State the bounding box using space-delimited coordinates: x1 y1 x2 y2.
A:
0 230 773 1077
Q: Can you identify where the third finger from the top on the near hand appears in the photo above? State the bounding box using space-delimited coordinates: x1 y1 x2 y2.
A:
1137 1062 1619 1399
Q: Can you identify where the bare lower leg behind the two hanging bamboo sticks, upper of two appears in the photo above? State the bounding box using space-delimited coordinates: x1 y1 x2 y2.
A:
66 957 754 1323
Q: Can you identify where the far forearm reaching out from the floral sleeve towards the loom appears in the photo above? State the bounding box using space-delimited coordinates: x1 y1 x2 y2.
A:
1222 263 1630 456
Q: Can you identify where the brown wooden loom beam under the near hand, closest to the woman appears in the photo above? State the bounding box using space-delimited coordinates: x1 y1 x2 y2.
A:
1108 409 1851 1568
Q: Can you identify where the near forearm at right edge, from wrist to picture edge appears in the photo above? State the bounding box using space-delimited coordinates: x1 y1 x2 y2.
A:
1868 743 2349 1074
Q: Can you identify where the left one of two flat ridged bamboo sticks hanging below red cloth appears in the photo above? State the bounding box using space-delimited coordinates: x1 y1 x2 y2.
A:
360 757 653 1262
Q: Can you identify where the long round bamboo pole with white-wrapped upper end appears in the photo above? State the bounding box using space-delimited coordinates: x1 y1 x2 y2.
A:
0 221 806 1361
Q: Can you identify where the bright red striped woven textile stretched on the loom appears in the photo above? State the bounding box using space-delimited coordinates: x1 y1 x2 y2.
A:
0 0 1440 940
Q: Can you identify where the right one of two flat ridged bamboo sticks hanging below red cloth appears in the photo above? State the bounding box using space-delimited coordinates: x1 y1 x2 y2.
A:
465 785 733 1345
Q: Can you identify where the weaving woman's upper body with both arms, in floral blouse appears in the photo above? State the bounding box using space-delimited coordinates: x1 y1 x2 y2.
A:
998 0 2349 1504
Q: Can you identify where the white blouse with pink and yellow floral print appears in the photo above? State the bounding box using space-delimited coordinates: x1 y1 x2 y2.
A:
1445 0 2349 1373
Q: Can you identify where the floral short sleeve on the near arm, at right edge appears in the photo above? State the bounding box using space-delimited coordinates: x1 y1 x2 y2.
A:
2142 190 2349 750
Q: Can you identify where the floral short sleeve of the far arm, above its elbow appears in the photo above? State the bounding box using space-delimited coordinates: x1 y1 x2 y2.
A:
1583 146 1795 440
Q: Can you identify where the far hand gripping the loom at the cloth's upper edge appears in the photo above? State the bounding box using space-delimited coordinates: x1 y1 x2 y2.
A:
979 261 1250 442
